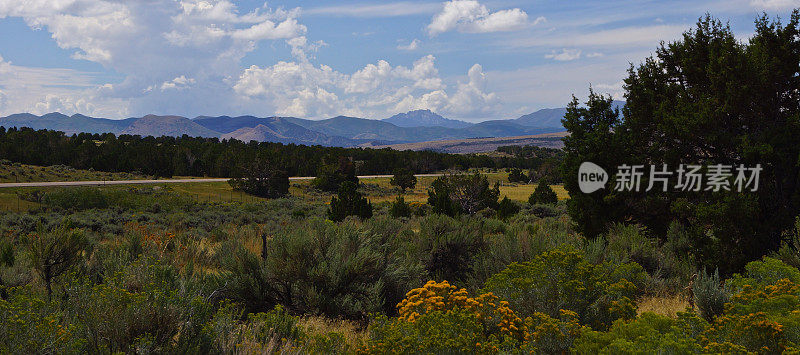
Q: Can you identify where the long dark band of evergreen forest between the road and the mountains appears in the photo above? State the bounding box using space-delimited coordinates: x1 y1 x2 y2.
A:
0 127 564 177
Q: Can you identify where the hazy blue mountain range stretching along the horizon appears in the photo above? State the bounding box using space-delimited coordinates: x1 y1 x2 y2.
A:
0 102 624 147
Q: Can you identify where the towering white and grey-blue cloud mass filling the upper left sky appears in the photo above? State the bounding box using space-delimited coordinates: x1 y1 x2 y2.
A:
0 0 306 114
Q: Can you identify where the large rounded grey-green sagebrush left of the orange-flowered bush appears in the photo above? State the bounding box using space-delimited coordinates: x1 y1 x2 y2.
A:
224 219 420 320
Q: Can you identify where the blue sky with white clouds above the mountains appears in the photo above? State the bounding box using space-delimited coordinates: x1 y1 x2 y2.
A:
0 0 800 122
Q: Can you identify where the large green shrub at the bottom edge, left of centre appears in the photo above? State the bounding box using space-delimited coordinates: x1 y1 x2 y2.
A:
63 259 213 353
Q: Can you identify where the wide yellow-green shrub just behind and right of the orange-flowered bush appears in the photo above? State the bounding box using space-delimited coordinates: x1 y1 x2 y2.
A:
483 246 645 329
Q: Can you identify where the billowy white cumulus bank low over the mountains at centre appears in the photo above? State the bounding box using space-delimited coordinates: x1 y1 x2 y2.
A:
234 55 499 117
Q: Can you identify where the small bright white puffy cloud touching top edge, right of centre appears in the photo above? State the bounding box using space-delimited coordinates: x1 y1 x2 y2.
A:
428 0 528 36
